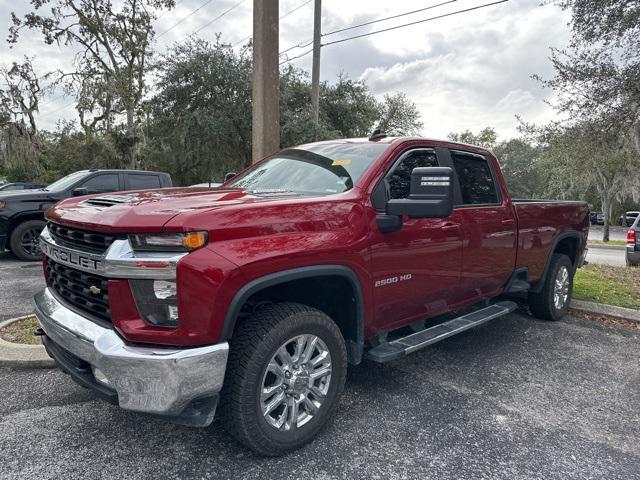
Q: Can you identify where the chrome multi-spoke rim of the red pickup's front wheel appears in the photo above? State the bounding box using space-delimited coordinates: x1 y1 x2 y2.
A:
260 335 331 431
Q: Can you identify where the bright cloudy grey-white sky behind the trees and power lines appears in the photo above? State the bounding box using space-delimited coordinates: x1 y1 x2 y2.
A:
0 0 569 138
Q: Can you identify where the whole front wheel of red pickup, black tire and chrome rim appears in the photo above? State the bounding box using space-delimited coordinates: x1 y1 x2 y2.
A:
219 303 347 456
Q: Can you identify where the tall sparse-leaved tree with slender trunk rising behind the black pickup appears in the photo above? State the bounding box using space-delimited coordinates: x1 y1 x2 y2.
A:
8 0 175 168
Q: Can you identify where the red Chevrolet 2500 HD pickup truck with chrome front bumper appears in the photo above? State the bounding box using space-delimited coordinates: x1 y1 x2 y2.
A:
35 134 589 455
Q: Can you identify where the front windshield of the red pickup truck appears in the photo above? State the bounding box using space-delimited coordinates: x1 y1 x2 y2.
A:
225 143 388 195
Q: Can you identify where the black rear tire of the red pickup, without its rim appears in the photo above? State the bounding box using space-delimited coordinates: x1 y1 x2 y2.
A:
529 253 575 321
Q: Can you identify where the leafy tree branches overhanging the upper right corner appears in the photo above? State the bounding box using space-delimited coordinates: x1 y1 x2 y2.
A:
535 0 640 152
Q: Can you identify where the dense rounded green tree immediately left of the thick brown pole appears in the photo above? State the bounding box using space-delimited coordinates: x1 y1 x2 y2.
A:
143 39 251 184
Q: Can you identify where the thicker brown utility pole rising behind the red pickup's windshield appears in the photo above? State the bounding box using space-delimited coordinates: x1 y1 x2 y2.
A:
252 0 280 163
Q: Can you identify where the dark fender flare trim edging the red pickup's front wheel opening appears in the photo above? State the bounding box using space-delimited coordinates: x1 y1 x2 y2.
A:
220 265 364 363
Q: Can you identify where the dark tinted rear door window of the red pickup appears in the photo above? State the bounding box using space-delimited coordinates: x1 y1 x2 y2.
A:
451 152 499 205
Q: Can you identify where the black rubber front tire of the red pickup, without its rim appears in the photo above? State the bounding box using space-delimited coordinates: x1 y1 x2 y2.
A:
218 303 347 456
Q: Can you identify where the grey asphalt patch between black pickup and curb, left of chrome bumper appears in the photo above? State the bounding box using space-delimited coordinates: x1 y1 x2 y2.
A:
0 252 44 321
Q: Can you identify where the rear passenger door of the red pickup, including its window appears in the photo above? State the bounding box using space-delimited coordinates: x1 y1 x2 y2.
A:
450 150 517 300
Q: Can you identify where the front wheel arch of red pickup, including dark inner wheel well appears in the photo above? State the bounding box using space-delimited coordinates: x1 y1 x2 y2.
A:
221 265 364 364
